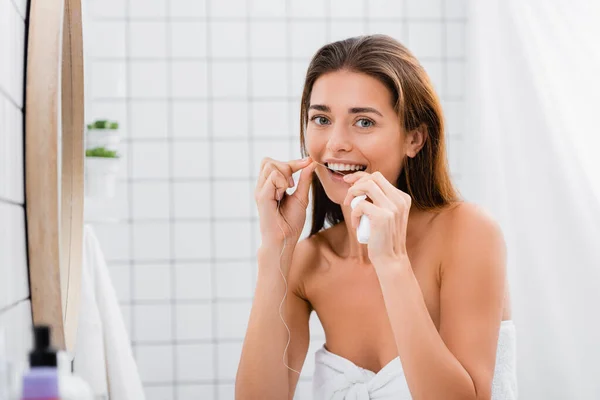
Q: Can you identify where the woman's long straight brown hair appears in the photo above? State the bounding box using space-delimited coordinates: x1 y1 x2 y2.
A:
300 35 459 235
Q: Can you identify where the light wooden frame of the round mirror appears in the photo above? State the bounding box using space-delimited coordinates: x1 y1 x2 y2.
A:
25 0 85 351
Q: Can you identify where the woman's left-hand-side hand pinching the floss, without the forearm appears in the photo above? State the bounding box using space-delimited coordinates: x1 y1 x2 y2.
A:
254 157 318 246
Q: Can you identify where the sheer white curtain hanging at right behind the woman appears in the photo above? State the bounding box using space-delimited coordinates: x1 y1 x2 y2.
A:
461 0 600 400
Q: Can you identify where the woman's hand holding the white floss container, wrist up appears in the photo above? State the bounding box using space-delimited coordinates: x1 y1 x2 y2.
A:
343 171 412 266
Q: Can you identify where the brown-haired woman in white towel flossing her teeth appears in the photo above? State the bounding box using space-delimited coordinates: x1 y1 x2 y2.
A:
236 35 516 400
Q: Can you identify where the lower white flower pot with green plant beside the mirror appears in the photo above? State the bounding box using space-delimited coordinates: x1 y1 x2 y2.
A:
85 157 119 198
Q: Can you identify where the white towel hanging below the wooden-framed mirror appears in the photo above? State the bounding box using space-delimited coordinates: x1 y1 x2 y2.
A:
74 225 145 400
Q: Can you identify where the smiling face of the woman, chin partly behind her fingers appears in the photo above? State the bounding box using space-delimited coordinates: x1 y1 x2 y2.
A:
305 71 405 204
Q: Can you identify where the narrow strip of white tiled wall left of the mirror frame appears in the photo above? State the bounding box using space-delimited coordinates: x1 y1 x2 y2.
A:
0 0 31 363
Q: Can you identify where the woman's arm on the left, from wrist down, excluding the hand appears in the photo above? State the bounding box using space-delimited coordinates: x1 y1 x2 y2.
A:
235 239 312 400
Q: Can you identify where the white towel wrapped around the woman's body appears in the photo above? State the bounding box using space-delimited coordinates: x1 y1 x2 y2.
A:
313 321 518 400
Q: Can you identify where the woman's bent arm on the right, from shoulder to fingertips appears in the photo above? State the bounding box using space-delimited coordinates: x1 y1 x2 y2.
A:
347 173 506 400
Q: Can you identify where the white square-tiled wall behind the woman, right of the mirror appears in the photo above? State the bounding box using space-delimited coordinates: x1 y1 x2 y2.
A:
84 0 466 400
